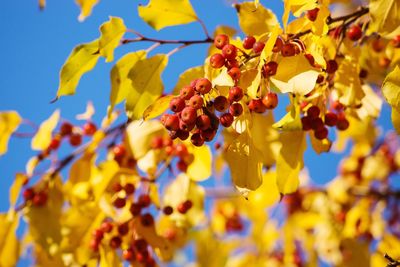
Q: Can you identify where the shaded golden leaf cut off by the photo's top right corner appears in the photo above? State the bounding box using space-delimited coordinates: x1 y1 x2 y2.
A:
369 0 400 35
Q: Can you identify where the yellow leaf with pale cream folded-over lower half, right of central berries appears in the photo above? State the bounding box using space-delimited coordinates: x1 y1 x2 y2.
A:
271 55 319 95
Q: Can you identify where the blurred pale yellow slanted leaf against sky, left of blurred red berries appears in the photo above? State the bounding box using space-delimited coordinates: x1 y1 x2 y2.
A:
31 110 60 150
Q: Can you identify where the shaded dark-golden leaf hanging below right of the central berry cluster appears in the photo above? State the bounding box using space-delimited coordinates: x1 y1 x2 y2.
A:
225 132 262 190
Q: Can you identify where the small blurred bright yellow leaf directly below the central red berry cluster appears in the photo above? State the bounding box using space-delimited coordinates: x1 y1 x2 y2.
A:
186 145 212 182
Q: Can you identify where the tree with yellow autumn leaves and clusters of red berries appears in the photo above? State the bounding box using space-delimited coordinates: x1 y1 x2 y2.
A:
0 0 400 266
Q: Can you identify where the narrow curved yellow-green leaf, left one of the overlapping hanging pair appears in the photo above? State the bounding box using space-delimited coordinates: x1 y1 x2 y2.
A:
108 50 146 115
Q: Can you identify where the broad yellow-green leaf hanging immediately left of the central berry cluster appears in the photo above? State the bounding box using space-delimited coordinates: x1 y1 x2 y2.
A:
125 55 168 119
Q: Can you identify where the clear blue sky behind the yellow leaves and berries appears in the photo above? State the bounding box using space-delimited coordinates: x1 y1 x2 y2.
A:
0 0 392 266
